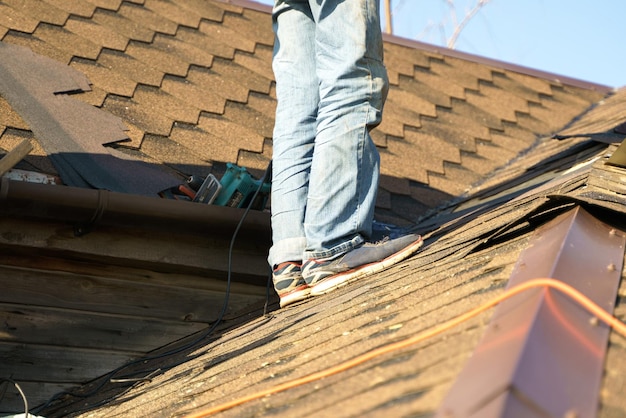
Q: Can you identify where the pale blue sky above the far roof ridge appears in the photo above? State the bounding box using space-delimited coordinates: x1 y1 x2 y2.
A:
251 0 626 87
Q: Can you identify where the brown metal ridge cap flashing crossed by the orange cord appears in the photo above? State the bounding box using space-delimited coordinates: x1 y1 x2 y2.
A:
438 206 626 418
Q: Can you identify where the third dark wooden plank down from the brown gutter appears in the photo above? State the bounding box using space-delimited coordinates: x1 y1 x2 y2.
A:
0 303 207 352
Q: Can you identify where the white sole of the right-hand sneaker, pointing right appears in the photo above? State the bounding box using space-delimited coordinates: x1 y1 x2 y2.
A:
310 237 424 296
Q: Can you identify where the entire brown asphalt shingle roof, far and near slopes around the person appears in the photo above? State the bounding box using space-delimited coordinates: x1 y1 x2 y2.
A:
0 0 626 418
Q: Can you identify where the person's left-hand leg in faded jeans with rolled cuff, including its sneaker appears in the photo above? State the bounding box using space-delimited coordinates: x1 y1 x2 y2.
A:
268 0 319 306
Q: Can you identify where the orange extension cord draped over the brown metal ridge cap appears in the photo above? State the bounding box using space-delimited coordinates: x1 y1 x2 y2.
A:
185 278 626 418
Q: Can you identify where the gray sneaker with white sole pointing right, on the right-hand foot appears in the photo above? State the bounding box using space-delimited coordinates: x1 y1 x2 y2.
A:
302 234 423 296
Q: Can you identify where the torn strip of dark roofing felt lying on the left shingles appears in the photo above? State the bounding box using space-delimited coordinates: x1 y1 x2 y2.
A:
0 42 180 195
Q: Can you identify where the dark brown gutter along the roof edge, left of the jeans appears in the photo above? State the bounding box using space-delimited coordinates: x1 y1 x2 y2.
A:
0 177 270 243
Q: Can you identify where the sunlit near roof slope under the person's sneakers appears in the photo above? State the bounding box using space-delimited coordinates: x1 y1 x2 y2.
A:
40 90 626 417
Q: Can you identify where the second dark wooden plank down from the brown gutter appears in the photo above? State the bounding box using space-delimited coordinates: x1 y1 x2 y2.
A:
0 266 265 322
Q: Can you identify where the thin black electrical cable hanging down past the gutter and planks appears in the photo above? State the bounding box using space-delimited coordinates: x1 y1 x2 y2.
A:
33 160 272 413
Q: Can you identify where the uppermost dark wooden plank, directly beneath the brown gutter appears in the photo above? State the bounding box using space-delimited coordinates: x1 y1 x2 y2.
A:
0 214 268 286
